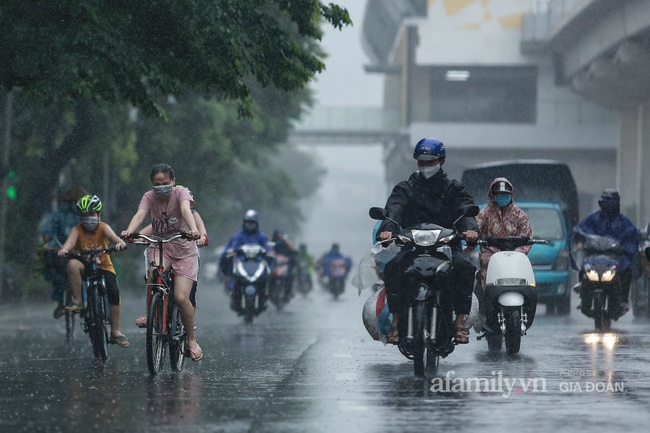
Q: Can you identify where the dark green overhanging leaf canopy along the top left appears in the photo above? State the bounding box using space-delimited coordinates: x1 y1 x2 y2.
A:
0 0 351 116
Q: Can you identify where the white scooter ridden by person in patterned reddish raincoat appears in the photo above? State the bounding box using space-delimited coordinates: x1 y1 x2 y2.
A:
475 236 548 355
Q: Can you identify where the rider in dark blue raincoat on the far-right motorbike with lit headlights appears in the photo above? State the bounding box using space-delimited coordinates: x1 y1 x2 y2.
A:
572 188 641 317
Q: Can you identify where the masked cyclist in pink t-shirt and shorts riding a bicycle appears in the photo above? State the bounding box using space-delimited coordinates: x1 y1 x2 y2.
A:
122 164 203 362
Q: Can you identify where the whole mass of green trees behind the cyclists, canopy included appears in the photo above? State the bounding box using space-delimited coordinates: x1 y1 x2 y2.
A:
0 0 351 294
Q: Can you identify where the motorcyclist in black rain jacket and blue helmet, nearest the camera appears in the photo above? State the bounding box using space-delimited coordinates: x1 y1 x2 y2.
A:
378 138 479 344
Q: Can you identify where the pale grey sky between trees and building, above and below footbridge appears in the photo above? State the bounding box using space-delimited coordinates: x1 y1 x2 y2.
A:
303 0 387 264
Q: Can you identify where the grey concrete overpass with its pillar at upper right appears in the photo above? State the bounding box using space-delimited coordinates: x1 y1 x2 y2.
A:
521 0 650 227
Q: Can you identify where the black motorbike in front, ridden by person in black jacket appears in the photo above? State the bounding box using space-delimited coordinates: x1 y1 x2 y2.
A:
370 206 479 377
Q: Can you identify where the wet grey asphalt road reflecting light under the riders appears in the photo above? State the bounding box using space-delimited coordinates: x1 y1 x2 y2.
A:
0 284 650 433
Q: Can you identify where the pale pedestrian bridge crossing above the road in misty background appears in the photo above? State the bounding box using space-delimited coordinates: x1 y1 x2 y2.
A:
289 107 400 145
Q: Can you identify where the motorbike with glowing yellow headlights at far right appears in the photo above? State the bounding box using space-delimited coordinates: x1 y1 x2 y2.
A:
570 232 624 331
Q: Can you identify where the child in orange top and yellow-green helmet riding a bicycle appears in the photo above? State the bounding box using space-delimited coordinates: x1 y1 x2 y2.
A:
57 195 129 347
